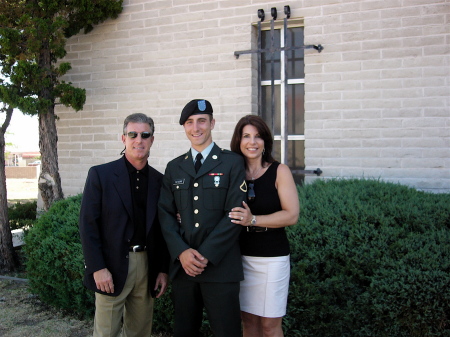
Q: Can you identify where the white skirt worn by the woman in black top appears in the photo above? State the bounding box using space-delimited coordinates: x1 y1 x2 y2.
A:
239 255 291 318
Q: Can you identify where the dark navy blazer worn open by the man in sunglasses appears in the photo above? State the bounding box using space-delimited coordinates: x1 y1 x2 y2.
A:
79 157 169 296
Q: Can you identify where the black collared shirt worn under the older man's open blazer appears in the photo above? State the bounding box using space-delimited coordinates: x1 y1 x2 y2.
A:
124 156 149 246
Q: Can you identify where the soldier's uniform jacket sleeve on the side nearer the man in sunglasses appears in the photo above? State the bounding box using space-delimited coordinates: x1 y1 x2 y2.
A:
158 165 190 261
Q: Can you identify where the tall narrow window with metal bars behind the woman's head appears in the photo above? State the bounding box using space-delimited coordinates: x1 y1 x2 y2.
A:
259 20 305 183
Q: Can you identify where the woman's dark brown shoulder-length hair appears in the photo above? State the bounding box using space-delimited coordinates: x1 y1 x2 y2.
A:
230 115 275 164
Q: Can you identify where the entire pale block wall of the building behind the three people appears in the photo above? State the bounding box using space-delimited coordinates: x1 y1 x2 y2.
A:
57 0 450 195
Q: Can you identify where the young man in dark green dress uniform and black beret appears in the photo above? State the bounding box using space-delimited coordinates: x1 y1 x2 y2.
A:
158 99 247 337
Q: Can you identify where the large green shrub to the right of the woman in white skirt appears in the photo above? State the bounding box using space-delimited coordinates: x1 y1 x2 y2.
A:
284 180 450 337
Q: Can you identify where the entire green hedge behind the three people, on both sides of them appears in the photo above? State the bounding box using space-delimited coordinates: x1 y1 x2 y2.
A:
26 179 450 337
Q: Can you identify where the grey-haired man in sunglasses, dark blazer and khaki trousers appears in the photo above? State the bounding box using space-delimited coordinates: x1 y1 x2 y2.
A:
79 113 169 337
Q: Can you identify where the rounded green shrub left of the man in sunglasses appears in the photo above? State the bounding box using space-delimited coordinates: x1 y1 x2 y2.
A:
24 194 94 317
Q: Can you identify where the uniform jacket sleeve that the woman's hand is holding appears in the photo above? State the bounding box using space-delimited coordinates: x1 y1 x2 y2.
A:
198 155 246 265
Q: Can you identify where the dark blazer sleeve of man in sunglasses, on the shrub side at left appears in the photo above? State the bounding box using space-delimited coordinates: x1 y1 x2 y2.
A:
78 168 106 274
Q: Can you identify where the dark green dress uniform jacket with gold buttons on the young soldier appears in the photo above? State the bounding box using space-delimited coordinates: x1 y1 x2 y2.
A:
158 144 247 282
